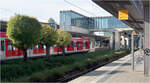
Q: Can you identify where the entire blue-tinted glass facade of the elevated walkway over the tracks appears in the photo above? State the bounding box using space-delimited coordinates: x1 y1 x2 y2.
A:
60 10 128 30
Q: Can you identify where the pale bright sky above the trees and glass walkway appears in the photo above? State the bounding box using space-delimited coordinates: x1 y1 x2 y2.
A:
0 0 111 24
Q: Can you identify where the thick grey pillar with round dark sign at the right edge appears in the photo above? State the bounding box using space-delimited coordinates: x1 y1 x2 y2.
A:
144 7 150 76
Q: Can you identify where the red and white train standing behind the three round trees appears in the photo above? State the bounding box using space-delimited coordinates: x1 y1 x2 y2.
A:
0 32 90 61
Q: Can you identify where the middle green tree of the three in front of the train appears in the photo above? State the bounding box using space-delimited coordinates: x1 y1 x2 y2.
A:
40 25 58 59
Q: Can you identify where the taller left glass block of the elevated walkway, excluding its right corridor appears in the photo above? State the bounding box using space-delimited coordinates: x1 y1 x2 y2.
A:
60 11 94 30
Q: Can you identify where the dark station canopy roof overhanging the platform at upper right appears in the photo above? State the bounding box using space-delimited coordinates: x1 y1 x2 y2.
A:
93 0 150 33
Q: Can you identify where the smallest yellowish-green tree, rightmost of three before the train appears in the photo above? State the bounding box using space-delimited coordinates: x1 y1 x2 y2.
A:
57 29 72 55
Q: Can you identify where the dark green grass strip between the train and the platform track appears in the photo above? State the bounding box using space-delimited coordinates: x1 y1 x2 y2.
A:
1 50 127 82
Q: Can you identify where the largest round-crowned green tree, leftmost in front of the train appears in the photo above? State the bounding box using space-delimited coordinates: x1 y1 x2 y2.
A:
7 15 42 62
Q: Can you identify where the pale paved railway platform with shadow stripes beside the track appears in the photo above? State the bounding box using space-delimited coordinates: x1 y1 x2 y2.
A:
69 52 150 83
